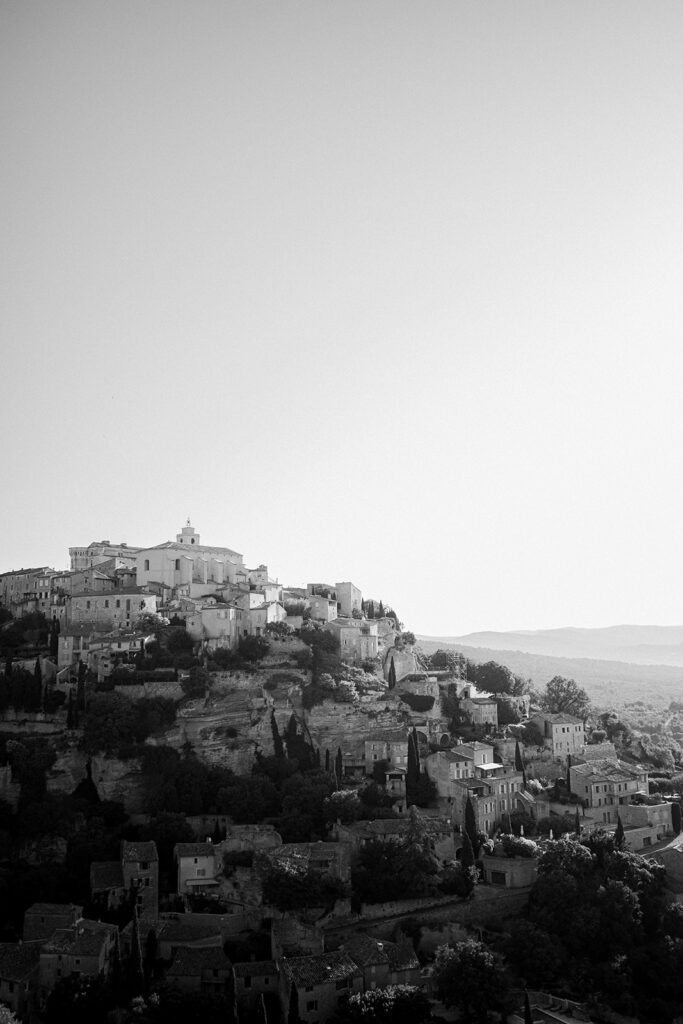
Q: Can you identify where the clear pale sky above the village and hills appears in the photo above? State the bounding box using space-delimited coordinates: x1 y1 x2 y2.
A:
0 0 683 636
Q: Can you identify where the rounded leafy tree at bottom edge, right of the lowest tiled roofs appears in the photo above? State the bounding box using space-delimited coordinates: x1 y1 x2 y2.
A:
434 939 511 1024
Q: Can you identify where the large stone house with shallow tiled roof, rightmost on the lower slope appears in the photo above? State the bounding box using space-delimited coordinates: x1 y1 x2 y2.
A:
569 758 649 824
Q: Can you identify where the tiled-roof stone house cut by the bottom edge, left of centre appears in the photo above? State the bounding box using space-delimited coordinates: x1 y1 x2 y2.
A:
279 950 362 1024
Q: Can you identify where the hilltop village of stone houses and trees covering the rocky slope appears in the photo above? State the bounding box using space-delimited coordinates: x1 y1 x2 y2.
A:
0 522 683 1024
